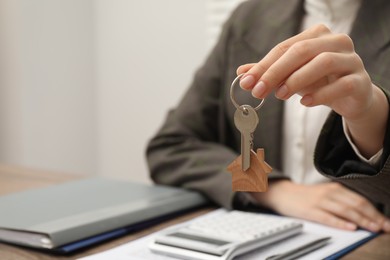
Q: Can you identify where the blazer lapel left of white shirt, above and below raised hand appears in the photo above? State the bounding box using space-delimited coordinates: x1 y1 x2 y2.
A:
238 0 304 170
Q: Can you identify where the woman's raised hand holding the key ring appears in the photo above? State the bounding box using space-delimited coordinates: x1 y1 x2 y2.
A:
237 25 389 158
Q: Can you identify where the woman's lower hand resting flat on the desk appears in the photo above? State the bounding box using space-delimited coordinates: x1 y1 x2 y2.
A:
251 180 390 232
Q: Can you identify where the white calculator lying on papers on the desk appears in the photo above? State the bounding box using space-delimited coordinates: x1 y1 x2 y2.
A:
149 211 303 260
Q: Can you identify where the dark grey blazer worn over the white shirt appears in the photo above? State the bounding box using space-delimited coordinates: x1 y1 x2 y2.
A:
147 0 390 215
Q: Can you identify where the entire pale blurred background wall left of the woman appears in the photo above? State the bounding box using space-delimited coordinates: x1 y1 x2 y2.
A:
0 0 242 182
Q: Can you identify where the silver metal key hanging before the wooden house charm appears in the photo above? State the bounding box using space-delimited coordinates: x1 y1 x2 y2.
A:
234 105 259 171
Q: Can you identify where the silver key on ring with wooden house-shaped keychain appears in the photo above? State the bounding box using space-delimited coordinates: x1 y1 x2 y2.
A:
227 75 272 192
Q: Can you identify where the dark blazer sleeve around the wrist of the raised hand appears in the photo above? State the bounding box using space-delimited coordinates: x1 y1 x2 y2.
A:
314 90 390 216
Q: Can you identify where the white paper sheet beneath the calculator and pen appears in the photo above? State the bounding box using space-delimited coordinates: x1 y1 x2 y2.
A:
79 209 372 260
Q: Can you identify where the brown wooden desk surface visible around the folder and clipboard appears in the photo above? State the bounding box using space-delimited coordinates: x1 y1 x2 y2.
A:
0 165 390 260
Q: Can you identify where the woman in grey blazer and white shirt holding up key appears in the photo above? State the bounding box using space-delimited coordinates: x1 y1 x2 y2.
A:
147 0 390 232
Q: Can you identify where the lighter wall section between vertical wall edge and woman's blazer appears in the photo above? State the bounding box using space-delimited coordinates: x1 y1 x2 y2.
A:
96 0 210 181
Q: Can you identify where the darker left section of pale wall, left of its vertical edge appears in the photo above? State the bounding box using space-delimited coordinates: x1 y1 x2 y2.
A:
0 0 97 174
